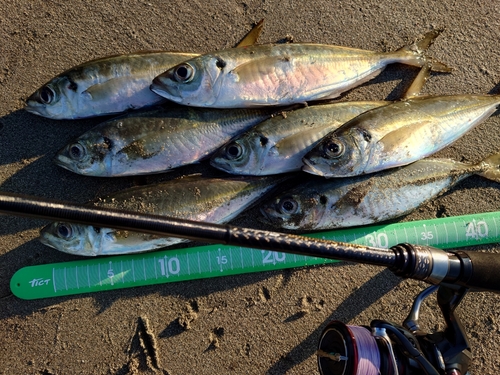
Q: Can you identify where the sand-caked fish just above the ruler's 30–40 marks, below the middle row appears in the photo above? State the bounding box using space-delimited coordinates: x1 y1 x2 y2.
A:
260 154 500 231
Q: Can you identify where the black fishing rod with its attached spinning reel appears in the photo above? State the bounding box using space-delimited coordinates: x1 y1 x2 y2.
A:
0 193 500 375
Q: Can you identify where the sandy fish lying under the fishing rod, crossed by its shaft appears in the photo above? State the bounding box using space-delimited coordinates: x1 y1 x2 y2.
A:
39 175 288 256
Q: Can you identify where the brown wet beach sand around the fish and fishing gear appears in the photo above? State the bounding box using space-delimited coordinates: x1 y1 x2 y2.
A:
0 0 500 375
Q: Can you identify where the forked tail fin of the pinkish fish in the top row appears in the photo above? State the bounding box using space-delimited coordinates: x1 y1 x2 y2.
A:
393 29 452 73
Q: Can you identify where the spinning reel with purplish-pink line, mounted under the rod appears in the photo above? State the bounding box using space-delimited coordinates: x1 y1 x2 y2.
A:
317 284 472 375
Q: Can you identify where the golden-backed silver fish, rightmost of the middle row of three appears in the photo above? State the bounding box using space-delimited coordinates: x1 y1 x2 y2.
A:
302 95 500 178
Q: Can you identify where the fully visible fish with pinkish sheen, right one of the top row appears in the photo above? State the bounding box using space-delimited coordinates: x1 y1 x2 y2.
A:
151 30 451 108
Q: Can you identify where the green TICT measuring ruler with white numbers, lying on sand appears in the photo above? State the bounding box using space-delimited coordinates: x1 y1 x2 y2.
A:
10 212 500 299
